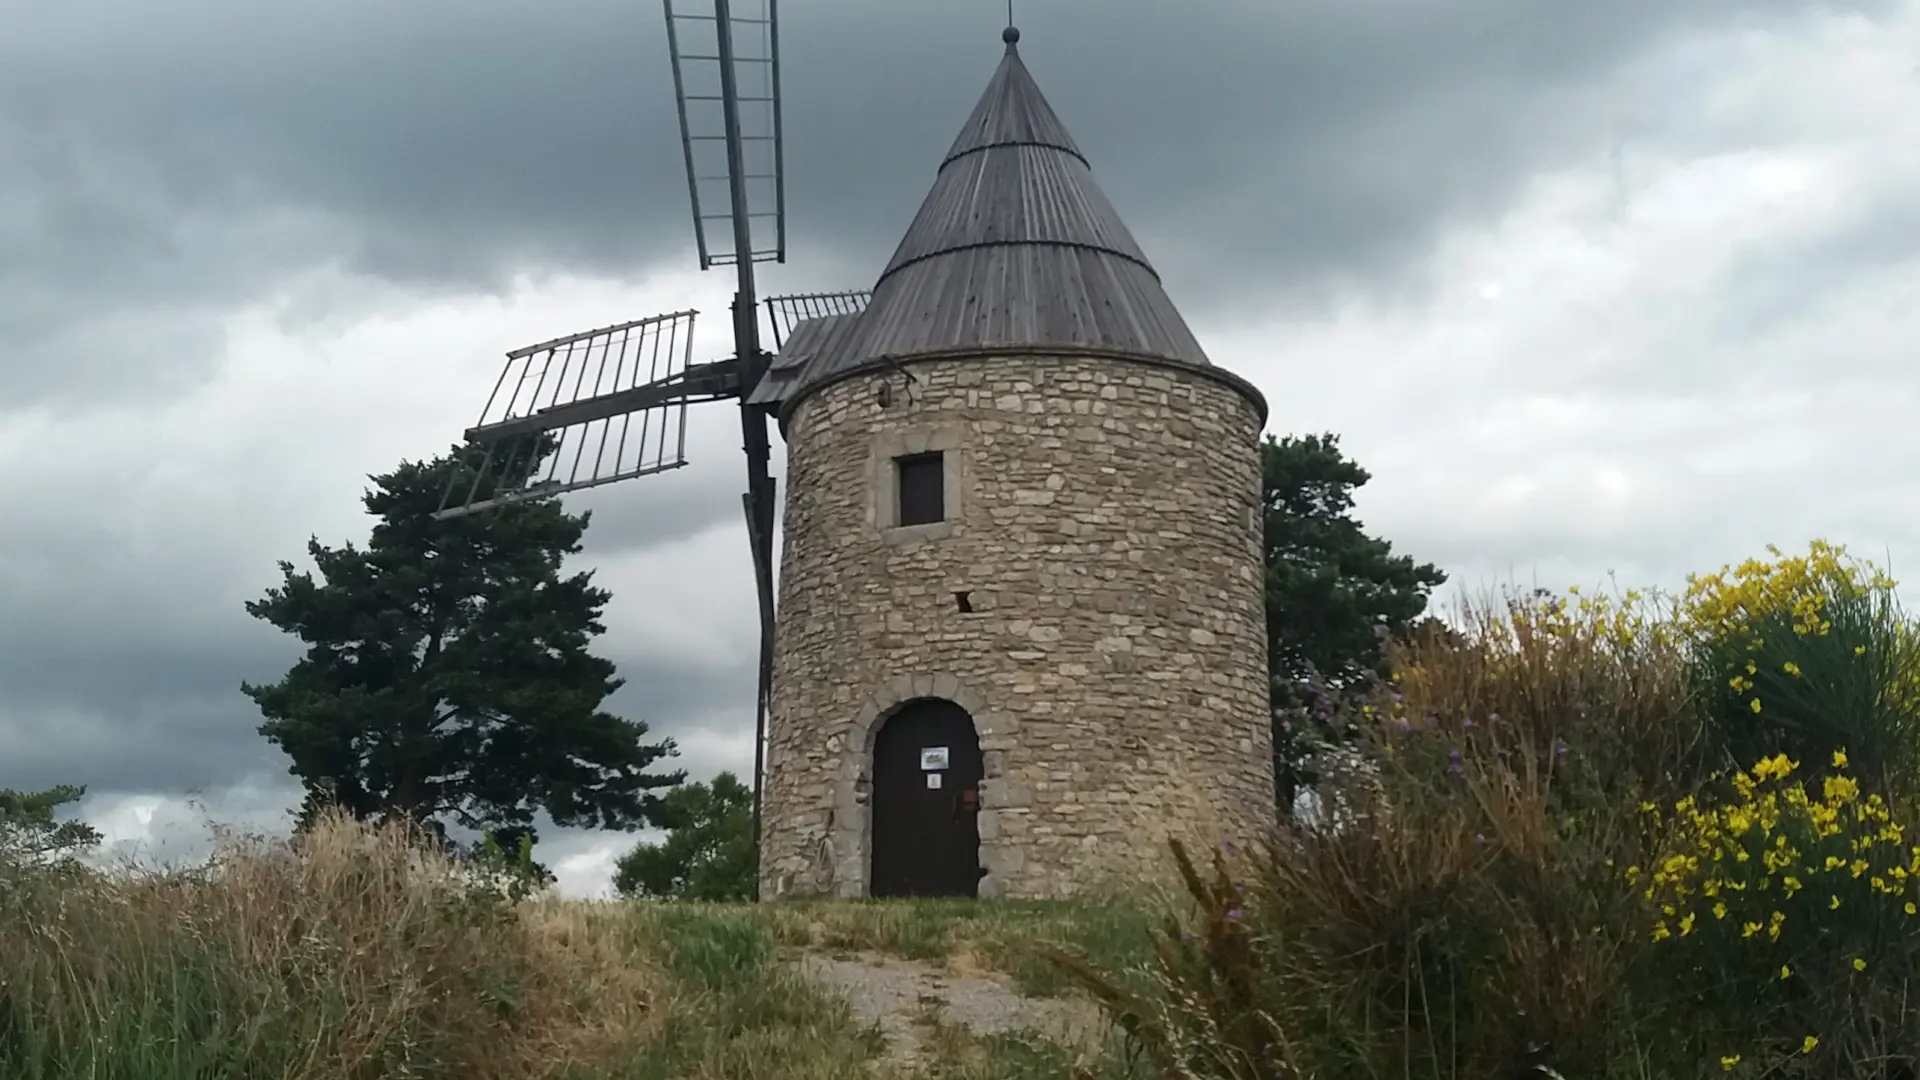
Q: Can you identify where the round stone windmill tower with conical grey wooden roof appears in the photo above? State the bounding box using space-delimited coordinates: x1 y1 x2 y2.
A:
756 29 1273 897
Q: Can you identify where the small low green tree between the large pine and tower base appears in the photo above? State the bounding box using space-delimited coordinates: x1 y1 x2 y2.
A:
612 773 758 899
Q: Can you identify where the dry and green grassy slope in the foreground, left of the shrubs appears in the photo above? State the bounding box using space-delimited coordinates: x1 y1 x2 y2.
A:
0 822 1144 1080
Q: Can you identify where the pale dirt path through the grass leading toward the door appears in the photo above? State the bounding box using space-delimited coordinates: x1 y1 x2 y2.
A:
795 953 1106 1068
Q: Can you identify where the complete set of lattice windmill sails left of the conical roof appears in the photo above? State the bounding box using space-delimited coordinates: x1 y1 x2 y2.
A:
436 0 868 891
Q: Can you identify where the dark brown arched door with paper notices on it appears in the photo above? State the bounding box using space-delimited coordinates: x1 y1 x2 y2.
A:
870 700 983 896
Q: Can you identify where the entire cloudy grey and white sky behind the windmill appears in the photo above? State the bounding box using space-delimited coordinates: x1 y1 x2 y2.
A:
0 0 1920 894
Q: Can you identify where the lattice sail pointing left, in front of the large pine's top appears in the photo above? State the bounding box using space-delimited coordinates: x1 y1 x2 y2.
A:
440 311 739 517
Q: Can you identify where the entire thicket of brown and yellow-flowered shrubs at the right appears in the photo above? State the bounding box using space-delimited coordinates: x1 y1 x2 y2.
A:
1060 544 1920 1080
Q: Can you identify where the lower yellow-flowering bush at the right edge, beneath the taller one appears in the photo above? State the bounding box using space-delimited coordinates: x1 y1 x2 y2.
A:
1622 751 1920 1074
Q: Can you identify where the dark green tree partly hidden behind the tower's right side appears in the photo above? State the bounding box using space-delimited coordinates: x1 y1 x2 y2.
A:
1261 434 1446 811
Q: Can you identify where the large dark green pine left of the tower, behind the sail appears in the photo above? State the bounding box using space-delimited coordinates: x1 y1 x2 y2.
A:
242 434 684 851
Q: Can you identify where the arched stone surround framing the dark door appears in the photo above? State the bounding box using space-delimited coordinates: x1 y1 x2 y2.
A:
829 673 1031 899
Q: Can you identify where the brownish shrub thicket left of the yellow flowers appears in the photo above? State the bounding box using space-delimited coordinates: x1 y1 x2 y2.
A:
1068 594 1701 1078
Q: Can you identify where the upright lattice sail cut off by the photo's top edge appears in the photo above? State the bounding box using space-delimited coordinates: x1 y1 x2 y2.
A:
662 0 787 269
